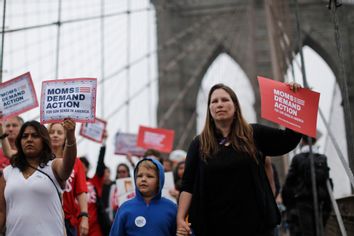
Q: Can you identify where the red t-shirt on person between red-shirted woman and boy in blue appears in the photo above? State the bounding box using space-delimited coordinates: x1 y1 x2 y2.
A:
87 175 103 236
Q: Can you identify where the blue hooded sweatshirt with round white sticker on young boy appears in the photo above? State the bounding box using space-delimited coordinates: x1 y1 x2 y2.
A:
109 158 177 236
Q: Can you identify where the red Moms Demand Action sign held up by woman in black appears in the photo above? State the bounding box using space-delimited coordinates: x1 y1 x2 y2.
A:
258 76 320 137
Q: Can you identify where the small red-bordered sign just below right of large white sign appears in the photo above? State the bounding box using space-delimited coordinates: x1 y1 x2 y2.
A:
80 118 107 143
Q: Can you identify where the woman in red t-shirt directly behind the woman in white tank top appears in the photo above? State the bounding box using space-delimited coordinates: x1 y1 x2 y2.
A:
48 123 89 236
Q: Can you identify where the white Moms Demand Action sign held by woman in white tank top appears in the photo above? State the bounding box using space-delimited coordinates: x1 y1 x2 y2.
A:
40 78 97 123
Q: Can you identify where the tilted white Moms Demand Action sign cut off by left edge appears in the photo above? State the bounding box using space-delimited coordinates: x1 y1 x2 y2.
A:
0 72 38 119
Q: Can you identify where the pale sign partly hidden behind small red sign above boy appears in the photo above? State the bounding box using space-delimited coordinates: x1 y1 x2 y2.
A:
114 132 146 157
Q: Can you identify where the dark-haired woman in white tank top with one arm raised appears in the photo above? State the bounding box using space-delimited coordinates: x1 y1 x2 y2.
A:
0 119 76 236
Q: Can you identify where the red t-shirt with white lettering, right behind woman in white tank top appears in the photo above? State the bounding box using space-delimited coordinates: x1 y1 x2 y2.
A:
63 158 87 226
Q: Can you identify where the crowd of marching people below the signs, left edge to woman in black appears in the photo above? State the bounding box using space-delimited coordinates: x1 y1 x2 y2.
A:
0 84 328 236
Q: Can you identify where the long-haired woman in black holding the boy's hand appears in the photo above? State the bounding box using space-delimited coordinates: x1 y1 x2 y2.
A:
177 84 301 236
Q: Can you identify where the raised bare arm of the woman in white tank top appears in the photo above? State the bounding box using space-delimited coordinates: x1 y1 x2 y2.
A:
53 118 77 181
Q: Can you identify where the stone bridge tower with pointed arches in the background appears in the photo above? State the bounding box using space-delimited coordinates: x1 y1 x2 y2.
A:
152 0 354 173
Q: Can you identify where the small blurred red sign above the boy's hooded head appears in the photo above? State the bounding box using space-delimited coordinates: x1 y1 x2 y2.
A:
137 126 175 153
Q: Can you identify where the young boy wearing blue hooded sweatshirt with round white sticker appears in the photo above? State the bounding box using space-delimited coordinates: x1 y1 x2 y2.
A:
110 158 177 236
